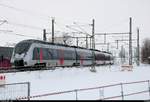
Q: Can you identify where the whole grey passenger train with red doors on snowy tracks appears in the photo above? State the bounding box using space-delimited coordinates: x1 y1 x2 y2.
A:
11 39 113 67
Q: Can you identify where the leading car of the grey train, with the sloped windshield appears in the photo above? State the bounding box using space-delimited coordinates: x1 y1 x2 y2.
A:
11 39 76 67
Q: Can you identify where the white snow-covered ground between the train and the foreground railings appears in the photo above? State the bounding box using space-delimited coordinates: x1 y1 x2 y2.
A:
1 64 150 100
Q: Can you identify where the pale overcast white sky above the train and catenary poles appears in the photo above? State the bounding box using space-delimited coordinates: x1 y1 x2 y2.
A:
0 0 150 49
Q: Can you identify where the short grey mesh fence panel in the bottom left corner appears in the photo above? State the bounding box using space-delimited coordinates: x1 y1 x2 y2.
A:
0 82 30 100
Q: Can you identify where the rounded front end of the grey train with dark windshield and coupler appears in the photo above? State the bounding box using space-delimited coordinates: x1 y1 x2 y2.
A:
11 41 31 67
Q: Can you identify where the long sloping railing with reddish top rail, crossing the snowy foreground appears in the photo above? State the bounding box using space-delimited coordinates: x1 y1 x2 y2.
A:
16 80 150 100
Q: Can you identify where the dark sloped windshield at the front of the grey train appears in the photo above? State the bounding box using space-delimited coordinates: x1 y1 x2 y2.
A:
15 42 31 54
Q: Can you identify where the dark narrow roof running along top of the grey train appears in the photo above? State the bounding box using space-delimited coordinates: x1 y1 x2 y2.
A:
17 39 111 54
